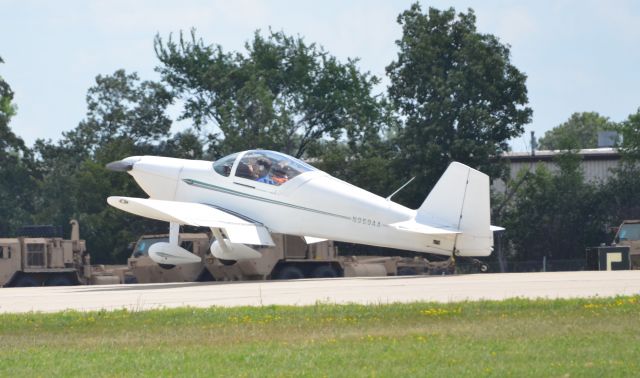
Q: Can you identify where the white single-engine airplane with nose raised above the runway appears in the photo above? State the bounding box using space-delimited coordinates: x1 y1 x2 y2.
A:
107 150 499 264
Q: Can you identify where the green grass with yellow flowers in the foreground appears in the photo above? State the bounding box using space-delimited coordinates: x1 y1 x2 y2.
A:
0 296 640 377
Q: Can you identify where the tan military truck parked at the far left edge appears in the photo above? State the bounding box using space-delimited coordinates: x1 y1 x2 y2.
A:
0 220 124 287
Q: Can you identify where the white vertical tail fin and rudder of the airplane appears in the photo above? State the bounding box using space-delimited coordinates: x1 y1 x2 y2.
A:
416 162 493 256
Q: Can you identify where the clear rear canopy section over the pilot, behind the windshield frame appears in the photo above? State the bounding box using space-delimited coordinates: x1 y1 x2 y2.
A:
235 150 316 186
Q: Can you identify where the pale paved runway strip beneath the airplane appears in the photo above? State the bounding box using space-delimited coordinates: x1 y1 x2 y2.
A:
0 271 640 313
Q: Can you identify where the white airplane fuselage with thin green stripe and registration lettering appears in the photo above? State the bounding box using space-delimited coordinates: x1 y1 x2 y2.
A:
129 156 455 256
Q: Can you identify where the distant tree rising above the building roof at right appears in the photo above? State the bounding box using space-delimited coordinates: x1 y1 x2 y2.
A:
538 112 617 150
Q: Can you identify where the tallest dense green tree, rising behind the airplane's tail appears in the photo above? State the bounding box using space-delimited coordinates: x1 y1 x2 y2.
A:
387 3 532 206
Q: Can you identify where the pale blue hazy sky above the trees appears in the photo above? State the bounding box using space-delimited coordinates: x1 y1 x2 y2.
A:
0 0 640 151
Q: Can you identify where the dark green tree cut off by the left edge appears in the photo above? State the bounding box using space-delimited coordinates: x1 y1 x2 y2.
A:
0 58 36 235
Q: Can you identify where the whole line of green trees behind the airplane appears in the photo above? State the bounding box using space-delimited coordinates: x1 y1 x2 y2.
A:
0 4 640 268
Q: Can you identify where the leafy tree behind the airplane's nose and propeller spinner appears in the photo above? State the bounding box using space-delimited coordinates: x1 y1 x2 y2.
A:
35 70 178 262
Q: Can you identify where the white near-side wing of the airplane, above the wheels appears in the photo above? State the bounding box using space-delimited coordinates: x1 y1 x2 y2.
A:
107 197 275 246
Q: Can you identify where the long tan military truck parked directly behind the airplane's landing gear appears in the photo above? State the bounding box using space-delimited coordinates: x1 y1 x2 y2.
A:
128 233 462 283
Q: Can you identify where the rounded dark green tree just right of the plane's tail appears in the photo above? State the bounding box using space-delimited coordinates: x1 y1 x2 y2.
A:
502 153 607 260
